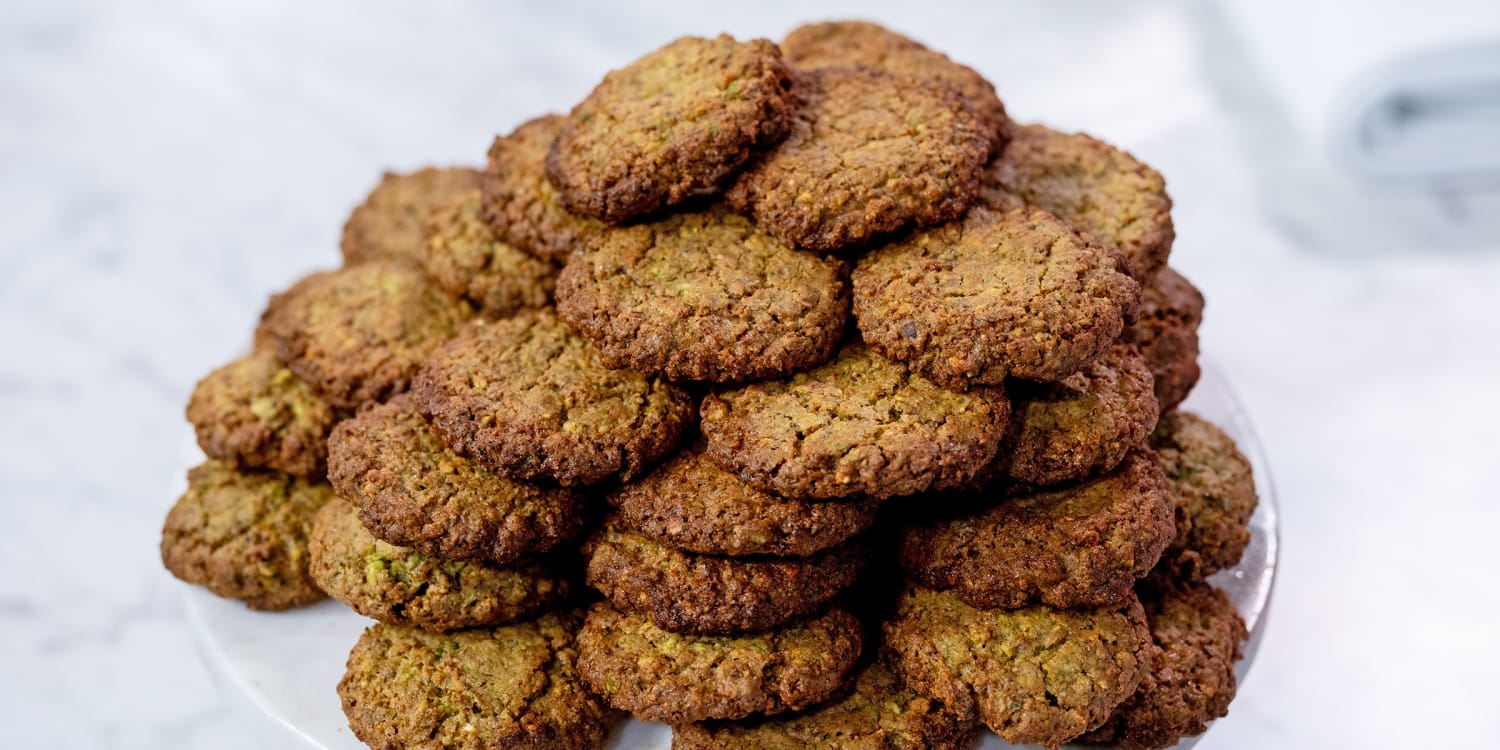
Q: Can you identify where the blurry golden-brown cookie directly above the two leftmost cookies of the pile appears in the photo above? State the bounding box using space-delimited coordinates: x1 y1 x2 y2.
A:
261 261 470 408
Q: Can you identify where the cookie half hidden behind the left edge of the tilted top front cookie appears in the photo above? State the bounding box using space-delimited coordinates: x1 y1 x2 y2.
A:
480 114 605 266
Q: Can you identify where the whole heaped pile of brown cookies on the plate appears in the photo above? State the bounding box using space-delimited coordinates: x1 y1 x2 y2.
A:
162 23 1256 749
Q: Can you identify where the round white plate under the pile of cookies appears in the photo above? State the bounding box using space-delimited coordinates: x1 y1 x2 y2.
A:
179 363 1278 750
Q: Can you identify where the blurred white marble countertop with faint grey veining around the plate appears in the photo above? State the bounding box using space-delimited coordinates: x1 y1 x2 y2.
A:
0 0 1500 750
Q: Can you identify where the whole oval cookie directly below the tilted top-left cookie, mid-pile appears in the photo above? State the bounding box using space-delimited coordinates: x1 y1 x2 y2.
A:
558 210 849 383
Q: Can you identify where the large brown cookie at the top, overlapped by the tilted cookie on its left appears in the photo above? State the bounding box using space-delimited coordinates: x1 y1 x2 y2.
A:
726 68 993 251
